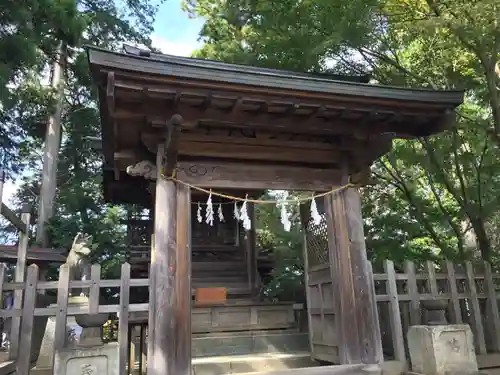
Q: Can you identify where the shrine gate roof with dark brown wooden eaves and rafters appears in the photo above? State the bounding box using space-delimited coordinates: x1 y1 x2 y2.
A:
88 47 463 207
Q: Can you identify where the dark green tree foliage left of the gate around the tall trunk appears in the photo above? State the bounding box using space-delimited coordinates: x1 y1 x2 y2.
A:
0 0 157 277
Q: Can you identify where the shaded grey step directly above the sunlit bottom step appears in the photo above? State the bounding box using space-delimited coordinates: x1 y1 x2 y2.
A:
191 329 309 358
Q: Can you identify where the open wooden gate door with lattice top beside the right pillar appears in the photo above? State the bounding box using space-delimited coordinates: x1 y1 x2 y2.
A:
300 202 339 363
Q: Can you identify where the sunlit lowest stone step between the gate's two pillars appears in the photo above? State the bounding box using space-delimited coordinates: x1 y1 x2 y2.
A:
192 352 317 375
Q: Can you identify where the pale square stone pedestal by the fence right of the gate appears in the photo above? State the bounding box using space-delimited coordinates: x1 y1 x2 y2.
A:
408 324 478 375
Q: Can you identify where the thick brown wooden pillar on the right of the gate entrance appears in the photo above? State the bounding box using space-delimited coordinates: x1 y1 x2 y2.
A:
325 188 383 364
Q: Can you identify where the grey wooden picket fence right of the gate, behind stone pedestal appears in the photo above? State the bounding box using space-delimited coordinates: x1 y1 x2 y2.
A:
374 260 500 366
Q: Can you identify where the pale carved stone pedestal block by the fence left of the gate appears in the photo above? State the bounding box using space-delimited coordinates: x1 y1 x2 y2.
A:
54 343 119 375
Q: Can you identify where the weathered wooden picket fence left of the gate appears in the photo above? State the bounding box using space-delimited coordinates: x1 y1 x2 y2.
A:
0 263 149 375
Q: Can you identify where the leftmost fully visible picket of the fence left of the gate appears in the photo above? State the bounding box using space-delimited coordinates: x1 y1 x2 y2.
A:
16 264 38 375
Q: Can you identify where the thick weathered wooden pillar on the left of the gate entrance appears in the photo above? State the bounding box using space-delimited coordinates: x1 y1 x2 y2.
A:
148 115 191 375
